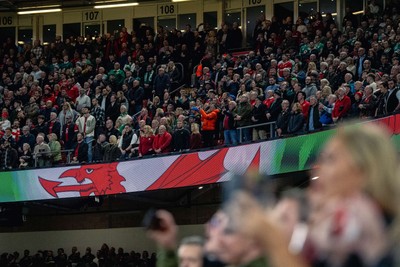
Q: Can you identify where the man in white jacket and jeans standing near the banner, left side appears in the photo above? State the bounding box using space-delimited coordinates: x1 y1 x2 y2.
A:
76 107 96 162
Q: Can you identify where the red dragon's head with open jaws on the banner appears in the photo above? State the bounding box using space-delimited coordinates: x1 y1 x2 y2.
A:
39 162 126 197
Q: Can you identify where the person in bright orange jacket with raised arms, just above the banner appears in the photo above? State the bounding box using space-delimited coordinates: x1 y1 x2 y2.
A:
200 103 219 147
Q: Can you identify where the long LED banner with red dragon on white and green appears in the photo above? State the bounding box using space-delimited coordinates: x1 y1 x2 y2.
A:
0 115 400 202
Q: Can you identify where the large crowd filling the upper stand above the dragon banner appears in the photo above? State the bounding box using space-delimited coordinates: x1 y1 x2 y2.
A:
0 2 400 170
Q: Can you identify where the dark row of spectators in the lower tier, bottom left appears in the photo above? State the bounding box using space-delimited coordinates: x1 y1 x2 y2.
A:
0 247 156 267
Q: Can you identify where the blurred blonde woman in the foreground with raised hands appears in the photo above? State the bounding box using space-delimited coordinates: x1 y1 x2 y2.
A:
225 124 400 267
